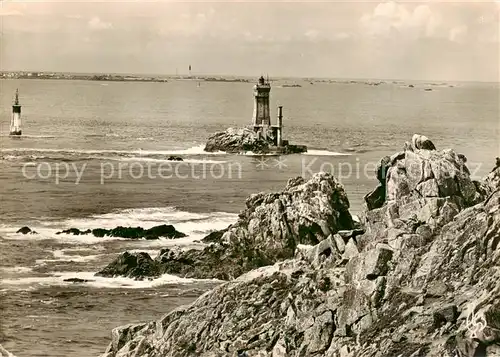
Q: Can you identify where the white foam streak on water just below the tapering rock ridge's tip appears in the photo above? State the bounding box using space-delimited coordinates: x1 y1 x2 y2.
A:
0 272 218 289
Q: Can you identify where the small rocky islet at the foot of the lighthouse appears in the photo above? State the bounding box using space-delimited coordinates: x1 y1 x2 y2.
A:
204 128 307 154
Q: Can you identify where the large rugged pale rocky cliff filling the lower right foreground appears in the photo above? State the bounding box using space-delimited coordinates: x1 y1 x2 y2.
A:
104 134 500 357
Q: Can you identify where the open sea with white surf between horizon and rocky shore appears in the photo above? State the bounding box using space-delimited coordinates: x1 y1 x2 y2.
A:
0 79 500 357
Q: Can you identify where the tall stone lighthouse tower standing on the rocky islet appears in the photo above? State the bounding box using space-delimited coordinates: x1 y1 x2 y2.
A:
252 76 271 138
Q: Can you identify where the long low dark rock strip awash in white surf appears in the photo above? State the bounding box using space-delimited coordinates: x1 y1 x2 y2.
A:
56 224 186 239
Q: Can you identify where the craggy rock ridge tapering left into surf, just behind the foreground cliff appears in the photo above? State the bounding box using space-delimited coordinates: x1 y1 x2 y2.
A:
99 173 354 280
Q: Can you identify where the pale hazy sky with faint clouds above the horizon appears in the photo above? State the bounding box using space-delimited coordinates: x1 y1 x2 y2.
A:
0 0 500 82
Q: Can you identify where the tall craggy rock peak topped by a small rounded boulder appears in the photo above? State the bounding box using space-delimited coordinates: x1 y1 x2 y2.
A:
362 135 486 250
